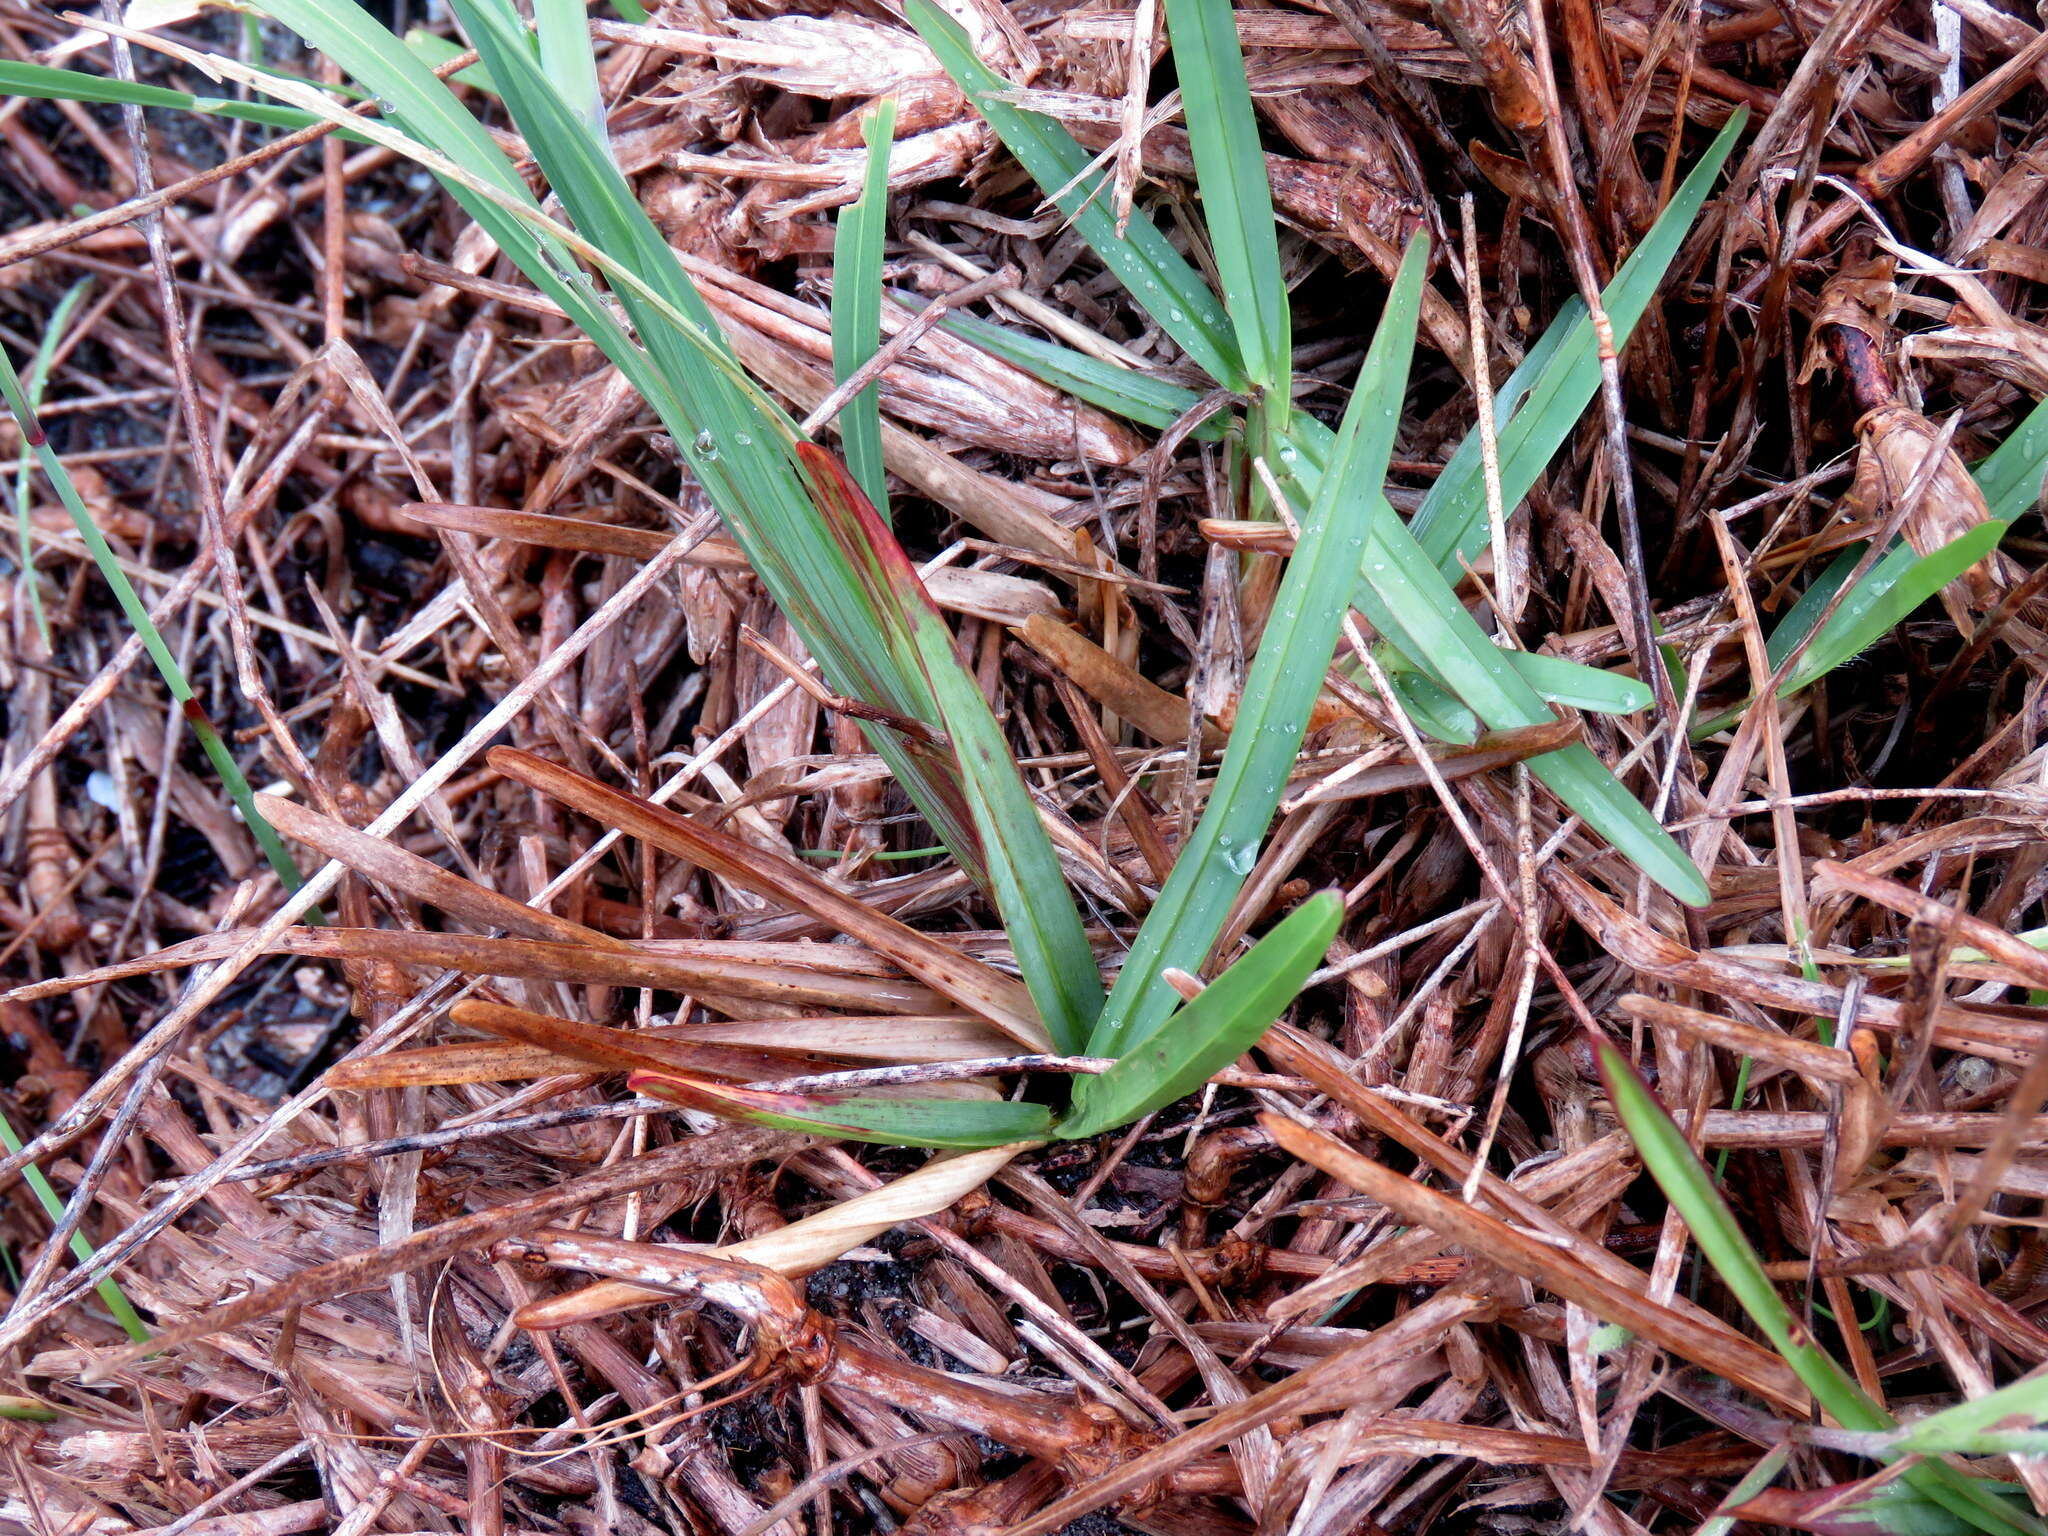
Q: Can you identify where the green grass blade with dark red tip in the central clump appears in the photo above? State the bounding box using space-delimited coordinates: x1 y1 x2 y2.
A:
803 444 1102 1055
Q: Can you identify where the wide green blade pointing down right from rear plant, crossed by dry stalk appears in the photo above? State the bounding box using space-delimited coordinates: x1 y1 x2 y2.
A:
1358 496 1712 907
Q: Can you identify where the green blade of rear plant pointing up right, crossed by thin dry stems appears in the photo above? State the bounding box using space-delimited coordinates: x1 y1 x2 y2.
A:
1413 106 1749 582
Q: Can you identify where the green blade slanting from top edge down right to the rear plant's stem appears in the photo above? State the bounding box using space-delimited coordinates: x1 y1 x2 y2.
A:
903 0 1247 393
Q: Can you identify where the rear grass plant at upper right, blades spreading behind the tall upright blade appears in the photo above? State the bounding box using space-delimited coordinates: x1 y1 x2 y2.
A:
905 0 1747 913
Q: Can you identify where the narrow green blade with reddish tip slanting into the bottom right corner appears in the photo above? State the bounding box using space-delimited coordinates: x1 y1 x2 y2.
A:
1593 1040 2044 1534
